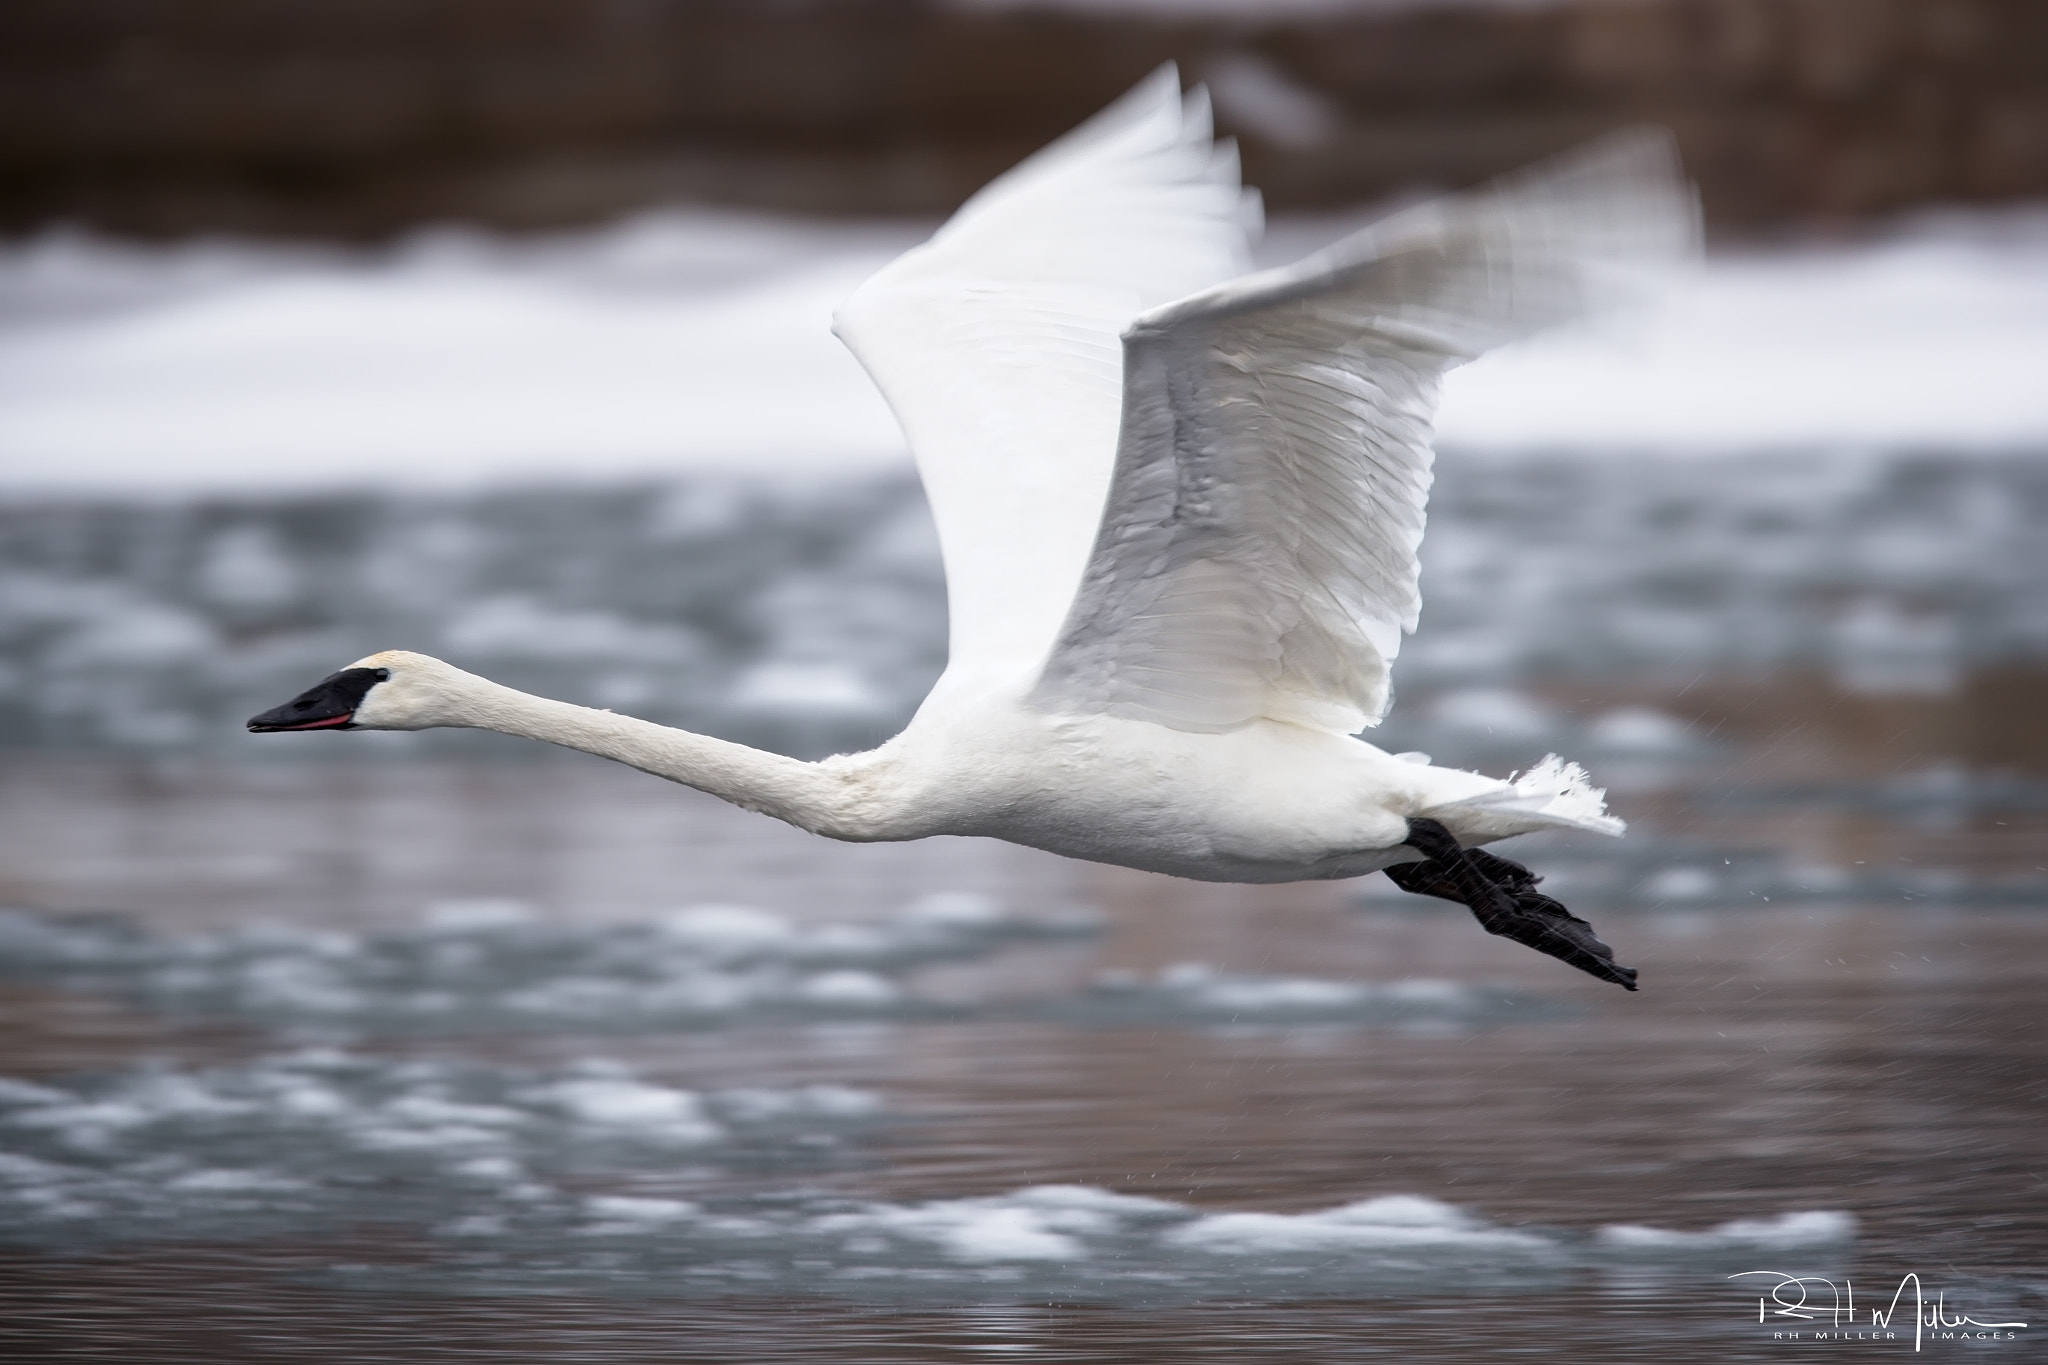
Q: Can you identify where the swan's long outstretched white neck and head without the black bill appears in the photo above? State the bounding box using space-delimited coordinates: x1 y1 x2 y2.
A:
374 655 909 839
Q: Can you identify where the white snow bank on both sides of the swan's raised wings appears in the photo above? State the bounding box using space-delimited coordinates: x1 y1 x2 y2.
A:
0 211 2048 493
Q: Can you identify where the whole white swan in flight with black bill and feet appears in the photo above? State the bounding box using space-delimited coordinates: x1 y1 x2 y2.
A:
248 68 1696 990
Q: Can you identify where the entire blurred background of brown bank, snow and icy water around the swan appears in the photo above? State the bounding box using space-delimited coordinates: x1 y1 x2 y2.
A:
0 0 2048 1361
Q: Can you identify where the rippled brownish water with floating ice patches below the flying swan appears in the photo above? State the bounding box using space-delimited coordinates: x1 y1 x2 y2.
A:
0 755 2048 1361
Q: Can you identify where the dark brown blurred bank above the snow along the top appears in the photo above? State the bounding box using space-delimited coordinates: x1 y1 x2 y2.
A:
0 0 2048 235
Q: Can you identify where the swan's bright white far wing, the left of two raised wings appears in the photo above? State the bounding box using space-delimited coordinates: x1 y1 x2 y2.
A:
834 65 1255 675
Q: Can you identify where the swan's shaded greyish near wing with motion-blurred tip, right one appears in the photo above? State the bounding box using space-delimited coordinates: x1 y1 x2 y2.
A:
1032 131 1698 733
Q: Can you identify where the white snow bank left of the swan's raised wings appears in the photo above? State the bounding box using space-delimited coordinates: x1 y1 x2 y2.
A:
0 215 915 487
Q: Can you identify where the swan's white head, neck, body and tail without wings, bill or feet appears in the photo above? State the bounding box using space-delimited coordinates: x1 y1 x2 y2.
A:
354 651 1620 882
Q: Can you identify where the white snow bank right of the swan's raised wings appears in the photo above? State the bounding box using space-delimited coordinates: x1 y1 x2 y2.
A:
1438 227 2048 454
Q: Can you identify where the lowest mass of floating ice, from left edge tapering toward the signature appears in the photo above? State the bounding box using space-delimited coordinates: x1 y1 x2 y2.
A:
0 1048 1853 1302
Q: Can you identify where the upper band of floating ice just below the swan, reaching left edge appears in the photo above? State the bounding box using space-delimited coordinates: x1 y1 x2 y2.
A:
0 892 1559 1033
